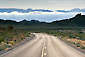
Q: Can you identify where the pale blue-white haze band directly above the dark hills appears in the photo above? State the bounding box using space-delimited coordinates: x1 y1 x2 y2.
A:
0 13 85 22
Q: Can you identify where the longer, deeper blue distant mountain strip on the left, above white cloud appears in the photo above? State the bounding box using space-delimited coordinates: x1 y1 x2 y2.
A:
0 8 53 13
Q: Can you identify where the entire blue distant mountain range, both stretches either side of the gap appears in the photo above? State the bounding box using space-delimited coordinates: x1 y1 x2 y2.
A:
0 8 85 13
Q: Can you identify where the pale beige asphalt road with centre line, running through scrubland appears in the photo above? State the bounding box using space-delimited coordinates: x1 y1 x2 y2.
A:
0 33 85 57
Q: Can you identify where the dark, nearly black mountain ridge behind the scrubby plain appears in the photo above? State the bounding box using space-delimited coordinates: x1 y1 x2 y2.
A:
0 14 85 29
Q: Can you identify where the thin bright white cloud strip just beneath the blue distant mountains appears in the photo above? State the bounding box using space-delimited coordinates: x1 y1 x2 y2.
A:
0 11 64 15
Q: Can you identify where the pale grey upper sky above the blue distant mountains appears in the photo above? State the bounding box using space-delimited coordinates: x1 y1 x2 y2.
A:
0 0 85 10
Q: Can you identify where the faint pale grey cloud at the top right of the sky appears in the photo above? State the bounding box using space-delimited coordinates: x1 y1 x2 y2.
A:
48 0 85 5
